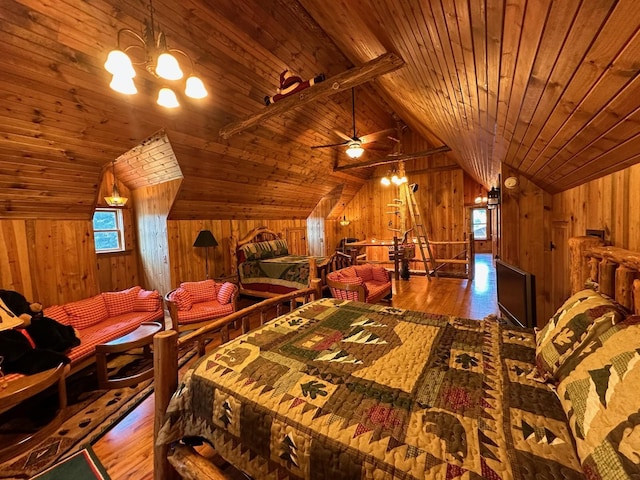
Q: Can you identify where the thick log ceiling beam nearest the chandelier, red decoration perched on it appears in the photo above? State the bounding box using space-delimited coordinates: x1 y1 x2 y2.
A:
220 53 404 139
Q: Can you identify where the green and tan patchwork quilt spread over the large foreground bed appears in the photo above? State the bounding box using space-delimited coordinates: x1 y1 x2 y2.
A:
158 299 584 480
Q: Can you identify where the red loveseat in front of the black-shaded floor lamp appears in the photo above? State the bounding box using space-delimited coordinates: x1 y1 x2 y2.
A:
164 280 239 332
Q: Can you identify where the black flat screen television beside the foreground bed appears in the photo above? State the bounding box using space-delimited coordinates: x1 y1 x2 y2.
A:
496 260 536 328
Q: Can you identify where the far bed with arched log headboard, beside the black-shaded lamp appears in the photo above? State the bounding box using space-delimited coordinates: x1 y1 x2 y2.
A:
229 227 348 298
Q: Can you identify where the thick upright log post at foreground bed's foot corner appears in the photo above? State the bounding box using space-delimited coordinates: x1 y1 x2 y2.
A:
153 330 180 480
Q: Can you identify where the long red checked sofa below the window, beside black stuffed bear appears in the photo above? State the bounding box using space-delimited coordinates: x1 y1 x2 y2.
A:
43 286 164 372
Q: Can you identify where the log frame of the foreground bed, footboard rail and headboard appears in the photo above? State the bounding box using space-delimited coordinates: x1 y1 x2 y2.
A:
154 237 640 480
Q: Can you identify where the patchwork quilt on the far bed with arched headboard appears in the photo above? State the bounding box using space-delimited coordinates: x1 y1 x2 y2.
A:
238 255 325 290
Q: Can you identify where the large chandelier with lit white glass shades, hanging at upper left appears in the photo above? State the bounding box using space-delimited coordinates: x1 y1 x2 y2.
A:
104 0 208 108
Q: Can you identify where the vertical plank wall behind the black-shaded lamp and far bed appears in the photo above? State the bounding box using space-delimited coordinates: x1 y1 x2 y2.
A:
165 219 307 293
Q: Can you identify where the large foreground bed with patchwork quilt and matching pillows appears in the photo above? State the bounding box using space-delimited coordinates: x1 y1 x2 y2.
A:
156 237 640 479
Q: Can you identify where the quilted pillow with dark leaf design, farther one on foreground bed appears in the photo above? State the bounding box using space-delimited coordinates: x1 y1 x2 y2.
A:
533 290 625 382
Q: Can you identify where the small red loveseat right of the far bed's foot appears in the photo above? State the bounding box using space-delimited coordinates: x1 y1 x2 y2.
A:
327 263 392 303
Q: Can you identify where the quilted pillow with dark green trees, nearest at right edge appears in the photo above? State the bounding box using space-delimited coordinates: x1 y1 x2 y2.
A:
557 316 640 479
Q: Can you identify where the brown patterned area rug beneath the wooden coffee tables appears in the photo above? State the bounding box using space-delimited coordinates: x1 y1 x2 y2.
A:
0 350 196 479
